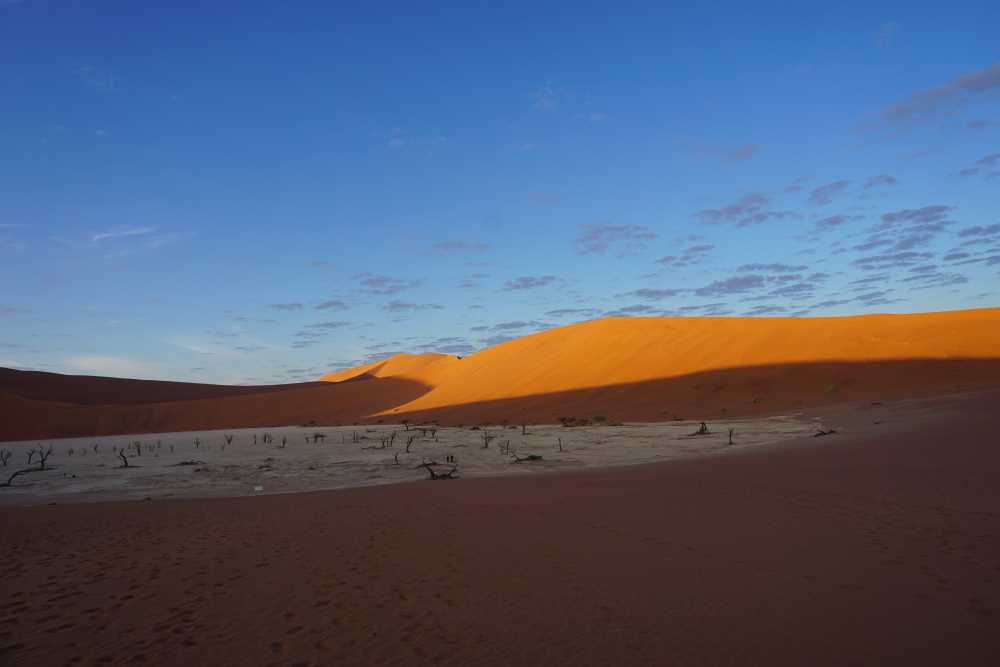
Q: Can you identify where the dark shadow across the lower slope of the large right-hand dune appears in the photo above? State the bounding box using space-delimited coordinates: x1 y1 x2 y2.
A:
376 359 1000 425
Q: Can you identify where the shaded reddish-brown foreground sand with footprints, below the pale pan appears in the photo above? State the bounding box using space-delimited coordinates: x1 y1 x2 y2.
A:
0 390 1000 665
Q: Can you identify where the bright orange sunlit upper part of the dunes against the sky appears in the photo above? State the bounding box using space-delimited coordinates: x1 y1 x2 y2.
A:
323 309 1000 418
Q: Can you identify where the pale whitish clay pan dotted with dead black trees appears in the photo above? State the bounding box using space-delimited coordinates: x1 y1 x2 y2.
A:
0 415 820 505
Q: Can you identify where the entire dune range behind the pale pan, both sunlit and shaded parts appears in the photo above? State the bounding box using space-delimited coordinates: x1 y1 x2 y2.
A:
0 308 1000 440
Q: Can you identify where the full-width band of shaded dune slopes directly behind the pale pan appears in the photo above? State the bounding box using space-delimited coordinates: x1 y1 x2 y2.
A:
0 358 1000 440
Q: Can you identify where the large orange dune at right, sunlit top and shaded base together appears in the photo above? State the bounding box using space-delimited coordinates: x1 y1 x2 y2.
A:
334 309 1000 420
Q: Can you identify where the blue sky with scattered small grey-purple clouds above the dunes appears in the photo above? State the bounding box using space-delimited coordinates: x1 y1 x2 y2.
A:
0 0 1000 383
